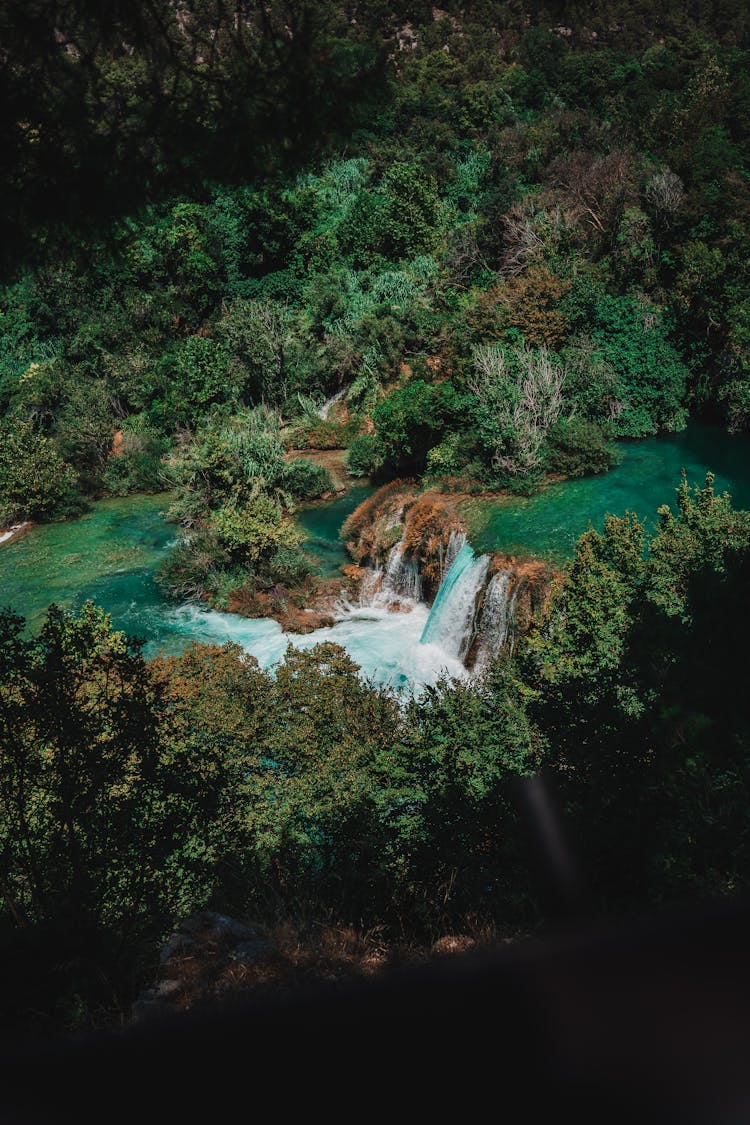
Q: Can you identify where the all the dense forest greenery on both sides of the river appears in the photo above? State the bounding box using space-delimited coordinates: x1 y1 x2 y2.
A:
0 0 750 1027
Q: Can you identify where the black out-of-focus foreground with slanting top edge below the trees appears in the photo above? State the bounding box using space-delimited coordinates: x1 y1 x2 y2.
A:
0 902 750 1125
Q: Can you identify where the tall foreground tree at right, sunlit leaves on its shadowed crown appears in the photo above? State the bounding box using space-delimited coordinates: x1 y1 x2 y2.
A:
523 476 750 900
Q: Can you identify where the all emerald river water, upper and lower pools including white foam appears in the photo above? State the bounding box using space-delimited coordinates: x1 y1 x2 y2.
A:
0 425 750 666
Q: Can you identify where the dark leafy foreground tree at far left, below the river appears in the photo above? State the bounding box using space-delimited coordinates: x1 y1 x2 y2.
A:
0 603 165 939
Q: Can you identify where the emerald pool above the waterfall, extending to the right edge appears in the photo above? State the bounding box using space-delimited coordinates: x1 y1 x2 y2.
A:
467 423 750 563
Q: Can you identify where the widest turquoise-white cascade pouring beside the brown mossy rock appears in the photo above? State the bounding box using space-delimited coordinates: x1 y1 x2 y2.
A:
421 542 489 660
